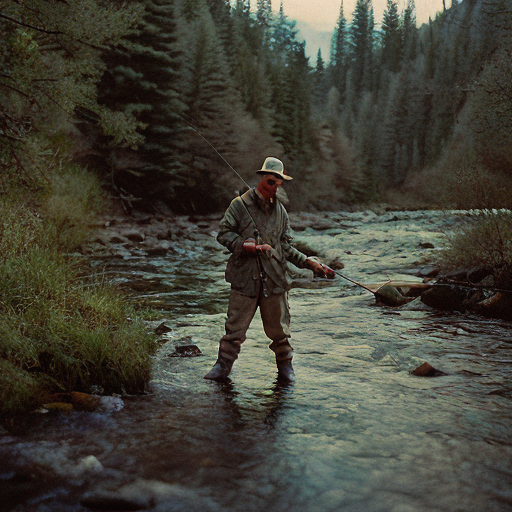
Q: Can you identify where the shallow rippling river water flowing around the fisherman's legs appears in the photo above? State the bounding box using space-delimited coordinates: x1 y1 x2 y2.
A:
0 212 512 512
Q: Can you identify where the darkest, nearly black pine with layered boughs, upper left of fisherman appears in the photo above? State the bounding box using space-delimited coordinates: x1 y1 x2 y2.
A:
97 0 186 197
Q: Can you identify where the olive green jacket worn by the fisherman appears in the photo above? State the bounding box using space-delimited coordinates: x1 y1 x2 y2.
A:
217 189 307 297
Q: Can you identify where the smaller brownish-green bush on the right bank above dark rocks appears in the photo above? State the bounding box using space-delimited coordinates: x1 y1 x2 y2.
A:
441 209 512 289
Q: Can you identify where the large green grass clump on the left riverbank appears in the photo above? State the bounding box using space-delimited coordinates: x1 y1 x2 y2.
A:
0 168 154 414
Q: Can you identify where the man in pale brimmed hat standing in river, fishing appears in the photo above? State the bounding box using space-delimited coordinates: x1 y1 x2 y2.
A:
204 157 335 382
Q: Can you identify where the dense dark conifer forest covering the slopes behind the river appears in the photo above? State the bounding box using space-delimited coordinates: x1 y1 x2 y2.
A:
0 0 512 213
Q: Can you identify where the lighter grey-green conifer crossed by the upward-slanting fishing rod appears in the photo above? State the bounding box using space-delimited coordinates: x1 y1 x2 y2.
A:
178 2 251 211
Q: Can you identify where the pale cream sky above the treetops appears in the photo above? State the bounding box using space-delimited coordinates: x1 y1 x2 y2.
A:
278 0 451 32
